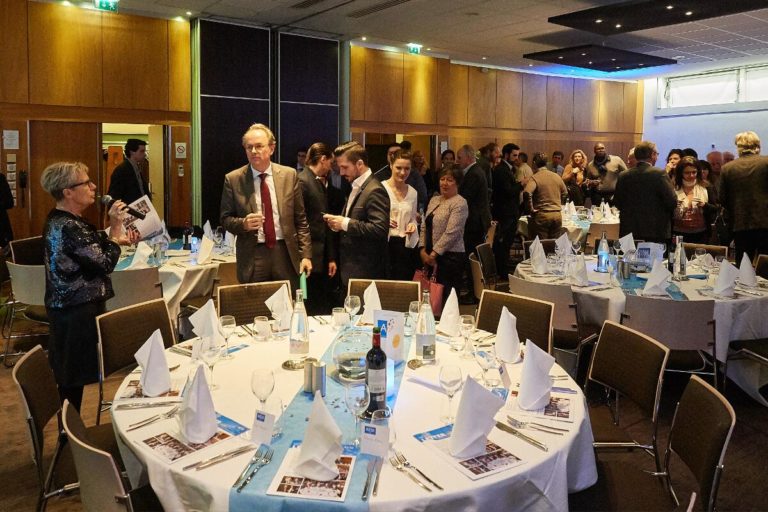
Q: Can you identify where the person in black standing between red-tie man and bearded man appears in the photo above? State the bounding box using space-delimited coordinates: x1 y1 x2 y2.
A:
299 142 344 315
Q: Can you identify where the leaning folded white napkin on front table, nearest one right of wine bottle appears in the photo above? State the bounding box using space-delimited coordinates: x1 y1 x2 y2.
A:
448 377 504 459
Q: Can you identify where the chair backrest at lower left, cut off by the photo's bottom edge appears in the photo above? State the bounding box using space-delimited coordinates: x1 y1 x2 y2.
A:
62 401 131 512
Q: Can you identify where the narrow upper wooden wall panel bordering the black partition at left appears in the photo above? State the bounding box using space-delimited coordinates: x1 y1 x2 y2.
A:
168 21 192 112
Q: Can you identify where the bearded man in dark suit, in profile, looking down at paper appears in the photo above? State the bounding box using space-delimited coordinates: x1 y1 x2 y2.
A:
323 141 390 288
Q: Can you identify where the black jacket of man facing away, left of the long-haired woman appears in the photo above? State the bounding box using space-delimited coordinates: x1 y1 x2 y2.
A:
613 162 677 241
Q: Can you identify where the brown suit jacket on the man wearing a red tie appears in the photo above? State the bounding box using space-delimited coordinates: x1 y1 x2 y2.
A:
220 162 312 283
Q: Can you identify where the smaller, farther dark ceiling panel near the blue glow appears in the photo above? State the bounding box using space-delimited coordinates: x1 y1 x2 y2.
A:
523 44 677 73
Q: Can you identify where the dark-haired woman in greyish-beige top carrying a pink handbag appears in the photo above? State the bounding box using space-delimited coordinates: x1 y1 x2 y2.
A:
421 165 469 304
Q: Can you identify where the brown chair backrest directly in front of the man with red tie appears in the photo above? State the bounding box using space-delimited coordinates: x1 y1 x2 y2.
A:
216 281 293 325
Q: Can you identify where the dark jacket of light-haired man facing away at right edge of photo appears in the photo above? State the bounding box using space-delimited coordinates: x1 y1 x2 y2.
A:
720 155 768 232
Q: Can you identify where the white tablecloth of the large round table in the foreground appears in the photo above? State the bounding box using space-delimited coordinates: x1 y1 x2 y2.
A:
112 317 597 512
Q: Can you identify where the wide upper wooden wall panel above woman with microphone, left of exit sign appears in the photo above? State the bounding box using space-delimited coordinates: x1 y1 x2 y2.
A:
29 2 102 107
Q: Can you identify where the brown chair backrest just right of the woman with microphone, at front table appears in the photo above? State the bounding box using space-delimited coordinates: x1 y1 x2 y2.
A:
96 299 175 381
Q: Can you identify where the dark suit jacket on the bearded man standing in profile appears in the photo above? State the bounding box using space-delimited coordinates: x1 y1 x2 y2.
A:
339 172 390 287
